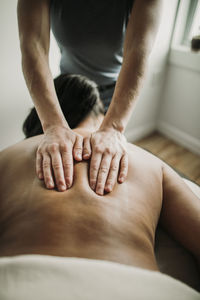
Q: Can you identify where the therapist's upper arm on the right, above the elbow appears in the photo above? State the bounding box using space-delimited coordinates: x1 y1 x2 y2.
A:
124 0 162 52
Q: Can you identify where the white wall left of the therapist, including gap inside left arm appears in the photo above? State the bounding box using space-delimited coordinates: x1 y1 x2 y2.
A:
0 0 59 150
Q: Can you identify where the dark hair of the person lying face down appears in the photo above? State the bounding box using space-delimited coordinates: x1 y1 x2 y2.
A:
23 74 104 138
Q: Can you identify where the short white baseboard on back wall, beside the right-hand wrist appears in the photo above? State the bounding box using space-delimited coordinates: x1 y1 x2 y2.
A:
125 122 156 142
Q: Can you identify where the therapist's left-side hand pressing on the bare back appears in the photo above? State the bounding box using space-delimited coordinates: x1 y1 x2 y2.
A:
36 126 83 191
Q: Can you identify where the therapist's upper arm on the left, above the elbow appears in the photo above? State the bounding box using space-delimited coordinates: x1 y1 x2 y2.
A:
17 0 50 53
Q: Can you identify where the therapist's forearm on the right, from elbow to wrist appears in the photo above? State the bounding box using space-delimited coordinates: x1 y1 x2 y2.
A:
101 50 147 132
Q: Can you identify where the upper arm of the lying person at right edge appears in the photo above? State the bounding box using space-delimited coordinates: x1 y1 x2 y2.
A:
160 164 200 259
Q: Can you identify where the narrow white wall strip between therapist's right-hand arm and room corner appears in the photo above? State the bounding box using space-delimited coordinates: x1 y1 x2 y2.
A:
126 0 178 141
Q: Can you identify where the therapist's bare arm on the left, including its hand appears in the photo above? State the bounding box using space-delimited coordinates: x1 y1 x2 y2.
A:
17 0 83 191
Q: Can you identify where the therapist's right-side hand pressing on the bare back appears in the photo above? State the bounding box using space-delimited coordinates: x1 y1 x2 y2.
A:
83 129 128 195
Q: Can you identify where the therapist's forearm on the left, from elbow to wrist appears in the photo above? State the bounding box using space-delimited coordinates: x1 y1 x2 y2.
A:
21 42 67 131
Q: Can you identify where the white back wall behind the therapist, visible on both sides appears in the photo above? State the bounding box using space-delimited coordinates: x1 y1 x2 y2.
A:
0 0 182 149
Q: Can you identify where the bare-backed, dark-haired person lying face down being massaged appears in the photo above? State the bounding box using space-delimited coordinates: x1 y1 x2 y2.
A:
0 75 200 278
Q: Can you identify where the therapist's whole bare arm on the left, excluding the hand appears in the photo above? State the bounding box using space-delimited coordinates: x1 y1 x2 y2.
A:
18 0 66 130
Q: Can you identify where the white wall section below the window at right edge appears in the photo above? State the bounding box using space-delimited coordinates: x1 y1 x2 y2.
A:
157 60 200 154
